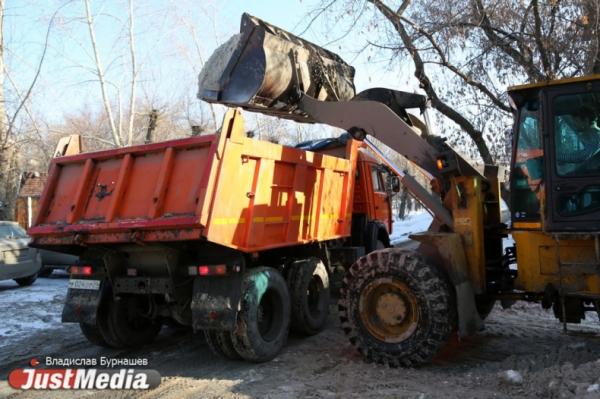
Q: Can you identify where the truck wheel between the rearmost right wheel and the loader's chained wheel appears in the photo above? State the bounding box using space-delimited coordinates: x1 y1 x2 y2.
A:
288 258 329 335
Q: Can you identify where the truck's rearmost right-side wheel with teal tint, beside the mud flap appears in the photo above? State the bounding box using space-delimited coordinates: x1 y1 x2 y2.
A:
231 267 290 362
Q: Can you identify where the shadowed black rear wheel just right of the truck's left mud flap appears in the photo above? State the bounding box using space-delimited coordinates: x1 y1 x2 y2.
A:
107 295 161 348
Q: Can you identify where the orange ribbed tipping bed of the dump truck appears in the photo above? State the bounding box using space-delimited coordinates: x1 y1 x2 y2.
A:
29 110 358 252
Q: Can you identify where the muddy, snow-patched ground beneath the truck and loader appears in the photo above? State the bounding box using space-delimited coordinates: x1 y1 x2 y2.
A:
0 276 600 399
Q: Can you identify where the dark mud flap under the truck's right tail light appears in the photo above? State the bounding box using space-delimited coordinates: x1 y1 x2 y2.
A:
191 273 242 331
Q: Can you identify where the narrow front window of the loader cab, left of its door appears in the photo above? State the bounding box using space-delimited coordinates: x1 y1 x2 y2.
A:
511 99 544 220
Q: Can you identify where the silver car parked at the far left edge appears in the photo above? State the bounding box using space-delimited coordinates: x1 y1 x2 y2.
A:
0 221 42 286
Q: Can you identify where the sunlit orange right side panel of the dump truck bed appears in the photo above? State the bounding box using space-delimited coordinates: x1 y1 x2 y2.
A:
206 130 358 252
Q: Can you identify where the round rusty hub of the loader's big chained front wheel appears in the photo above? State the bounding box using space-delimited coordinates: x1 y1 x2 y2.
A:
359 277 420 343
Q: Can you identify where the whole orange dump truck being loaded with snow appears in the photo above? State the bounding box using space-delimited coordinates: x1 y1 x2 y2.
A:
29 109 398 361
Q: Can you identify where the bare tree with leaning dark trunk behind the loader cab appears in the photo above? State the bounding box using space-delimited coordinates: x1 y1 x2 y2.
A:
315 0 600 163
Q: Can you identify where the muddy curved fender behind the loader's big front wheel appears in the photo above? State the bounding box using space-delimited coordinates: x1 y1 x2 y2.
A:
410 231 483 338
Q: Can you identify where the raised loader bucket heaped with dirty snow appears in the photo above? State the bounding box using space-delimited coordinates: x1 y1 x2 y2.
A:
198 14 355 122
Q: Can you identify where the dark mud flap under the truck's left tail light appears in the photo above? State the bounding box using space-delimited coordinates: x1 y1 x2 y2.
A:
62 281 106 325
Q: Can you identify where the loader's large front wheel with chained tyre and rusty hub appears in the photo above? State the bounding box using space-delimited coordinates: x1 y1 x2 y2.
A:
339 248 456 367
